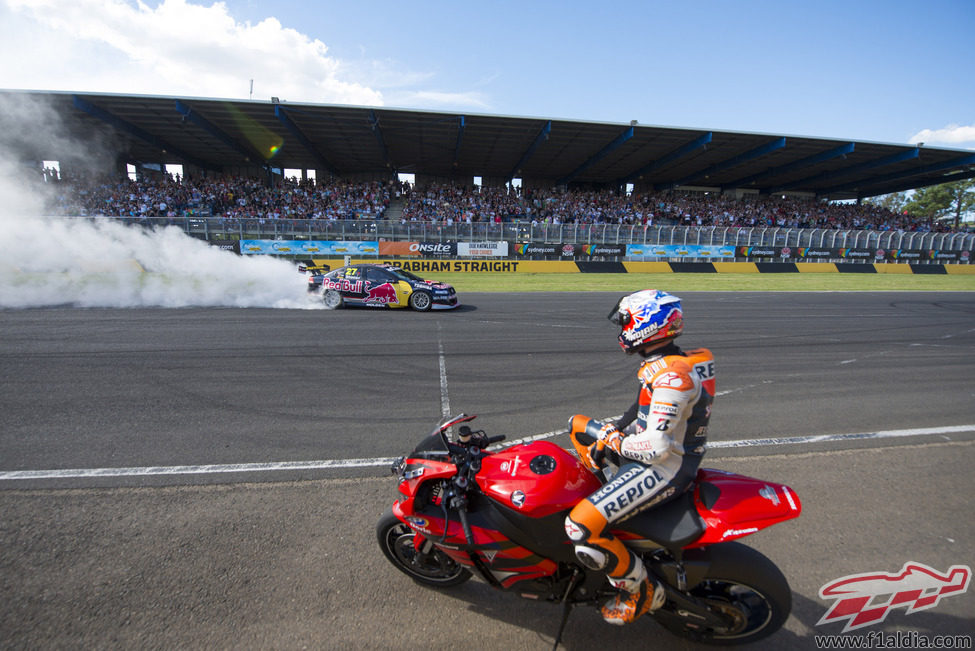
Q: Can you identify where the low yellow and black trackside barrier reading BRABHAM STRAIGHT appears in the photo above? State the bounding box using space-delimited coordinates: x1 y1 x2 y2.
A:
302 258 975 275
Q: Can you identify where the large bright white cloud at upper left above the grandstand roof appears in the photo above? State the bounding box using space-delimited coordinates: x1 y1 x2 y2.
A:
0 0 384 106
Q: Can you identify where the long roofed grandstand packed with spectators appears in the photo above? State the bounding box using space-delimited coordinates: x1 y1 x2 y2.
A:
0 91 975 258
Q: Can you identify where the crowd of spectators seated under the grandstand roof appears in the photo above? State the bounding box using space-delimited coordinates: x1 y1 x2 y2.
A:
42 175 950 231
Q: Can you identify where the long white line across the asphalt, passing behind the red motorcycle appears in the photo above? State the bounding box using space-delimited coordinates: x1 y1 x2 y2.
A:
0 426 975 481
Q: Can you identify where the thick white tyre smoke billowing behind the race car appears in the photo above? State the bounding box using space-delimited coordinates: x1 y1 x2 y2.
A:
0 97 321 309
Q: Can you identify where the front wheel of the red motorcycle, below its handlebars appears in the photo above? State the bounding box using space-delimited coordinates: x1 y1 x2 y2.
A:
376 510 472 588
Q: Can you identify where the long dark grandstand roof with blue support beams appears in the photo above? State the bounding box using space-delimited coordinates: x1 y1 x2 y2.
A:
7 90 975 199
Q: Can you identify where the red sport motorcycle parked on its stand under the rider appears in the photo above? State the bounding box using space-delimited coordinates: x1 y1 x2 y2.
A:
376 414 802 648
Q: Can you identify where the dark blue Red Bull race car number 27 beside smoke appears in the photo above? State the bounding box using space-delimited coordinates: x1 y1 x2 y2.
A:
308 264 460 312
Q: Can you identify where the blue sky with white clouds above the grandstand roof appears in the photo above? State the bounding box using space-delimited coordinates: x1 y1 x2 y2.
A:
0 0 975 149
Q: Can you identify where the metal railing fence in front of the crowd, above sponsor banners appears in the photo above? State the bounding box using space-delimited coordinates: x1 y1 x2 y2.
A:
63 217 975 251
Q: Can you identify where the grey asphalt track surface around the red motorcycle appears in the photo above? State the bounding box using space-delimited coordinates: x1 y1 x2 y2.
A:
0 292 975 649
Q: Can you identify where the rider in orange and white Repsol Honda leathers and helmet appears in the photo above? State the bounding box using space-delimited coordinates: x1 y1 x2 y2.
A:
565 289 714 624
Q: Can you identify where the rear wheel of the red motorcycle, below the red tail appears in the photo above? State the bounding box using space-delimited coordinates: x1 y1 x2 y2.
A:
654 542 792 645
